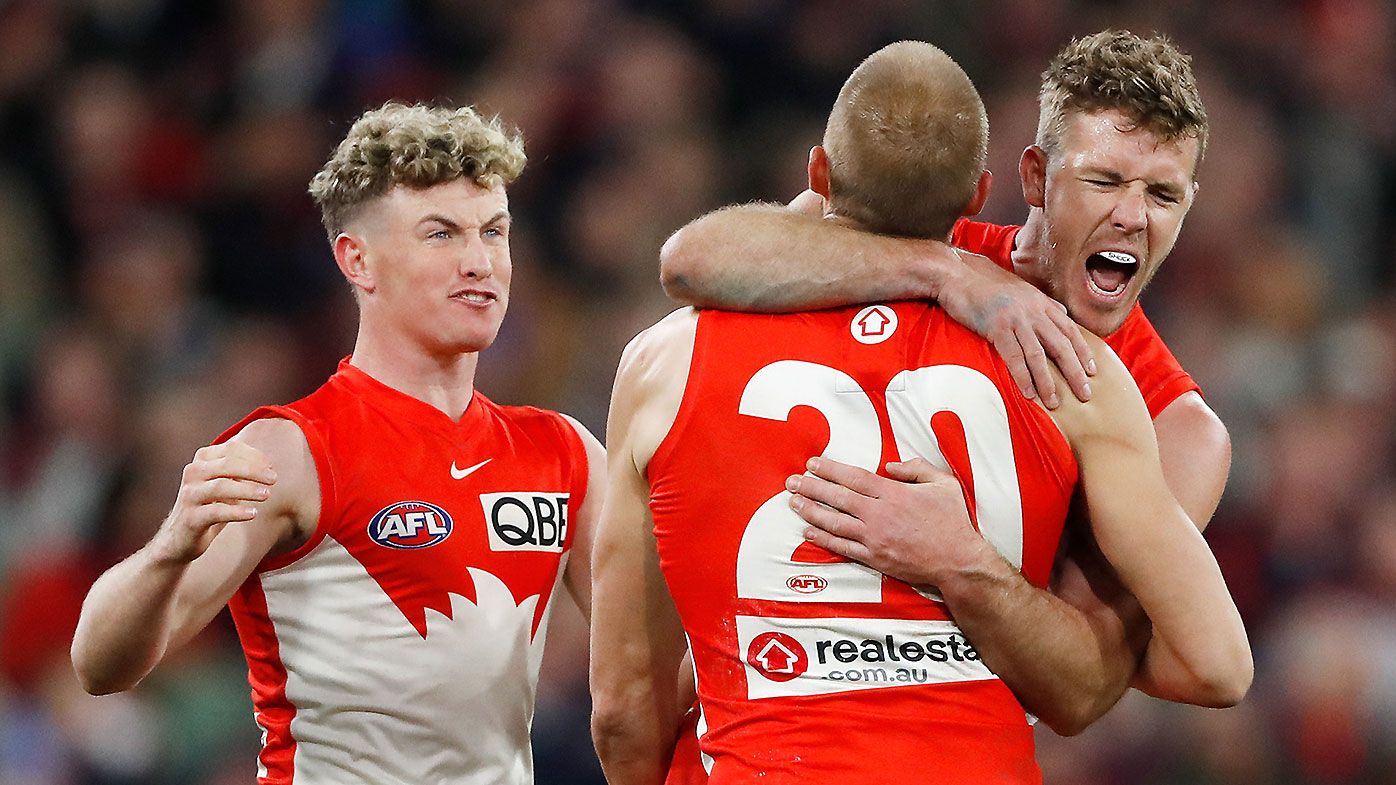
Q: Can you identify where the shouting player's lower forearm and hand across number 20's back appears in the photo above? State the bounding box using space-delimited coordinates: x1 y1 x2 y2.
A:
787 458 1142 735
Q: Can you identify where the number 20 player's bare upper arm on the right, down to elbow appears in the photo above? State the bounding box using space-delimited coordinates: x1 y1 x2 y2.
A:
1054 332 1254 705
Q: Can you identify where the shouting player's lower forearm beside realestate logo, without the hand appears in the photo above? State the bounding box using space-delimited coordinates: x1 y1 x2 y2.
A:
940 550 1135 735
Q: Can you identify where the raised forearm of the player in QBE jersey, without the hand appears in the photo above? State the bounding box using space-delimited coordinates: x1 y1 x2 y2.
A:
71 546 187 694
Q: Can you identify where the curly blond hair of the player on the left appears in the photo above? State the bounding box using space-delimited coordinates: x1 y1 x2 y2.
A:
310 102 528 240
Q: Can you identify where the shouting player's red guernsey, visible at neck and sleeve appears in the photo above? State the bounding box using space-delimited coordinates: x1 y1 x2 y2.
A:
951 218 1202 418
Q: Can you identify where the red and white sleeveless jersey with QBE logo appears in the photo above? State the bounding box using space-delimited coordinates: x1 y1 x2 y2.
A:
213 360 586 785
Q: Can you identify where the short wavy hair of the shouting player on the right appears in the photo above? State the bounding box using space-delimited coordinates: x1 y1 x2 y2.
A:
1037 29 1208 171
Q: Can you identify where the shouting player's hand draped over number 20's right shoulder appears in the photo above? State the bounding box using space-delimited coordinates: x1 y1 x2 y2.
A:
937 249 1096 409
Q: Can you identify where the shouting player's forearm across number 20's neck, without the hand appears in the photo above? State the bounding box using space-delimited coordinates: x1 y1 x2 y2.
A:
660 204 960 313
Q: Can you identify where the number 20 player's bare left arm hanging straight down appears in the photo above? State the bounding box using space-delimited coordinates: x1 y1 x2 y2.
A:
591 309 697 785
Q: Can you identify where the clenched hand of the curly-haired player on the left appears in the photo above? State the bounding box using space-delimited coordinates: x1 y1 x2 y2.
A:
151 441 276 563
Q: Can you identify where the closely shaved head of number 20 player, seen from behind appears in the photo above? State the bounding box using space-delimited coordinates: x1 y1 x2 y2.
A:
824 41 988 239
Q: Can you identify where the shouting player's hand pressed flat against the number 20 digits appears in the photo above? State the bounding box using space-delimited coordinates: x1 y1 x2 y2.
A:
786 458 997 587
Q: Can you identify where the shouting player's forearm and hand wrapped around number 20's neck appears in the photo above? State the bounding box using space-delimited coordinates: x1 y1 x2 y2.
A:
660 191 1094 408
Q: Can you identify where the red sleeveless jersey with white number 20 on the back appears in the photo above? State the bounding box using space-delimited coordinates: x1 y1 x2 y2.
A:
648 303 1076 785
